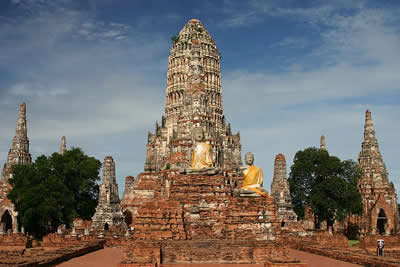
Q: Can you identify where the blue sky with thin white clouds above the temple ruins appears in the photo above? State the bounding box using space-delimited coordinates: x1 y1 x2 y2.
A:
0 0 400 197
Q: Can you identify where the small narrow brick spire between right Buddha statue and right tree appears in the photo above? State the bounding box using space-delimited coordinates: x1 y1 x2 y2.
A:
271 154 297 226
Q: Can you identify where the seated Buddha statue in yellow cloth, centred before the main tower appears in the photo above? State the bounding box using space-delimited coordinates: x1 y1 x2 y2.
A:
184 128 220 174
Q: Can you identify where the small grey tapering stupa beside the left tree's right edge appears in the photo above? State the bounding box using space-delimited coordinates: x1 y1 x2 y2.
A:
92 156 125 230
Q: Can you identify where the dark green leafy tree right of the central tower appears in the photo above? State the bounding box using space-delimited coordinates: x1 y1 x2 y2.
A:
289 147 362 228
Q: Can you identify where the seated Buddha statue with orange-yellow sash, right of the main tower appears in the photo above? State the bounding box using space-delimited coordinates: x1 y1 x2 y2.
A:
234 152 269 197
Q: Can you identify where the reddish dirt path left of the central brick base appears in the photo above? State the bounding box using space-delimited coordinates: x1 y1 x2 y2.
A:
57 248 123 267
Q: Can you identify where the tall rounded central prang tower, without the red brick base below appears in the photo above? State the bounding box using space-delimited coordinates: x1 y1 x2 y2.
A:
144 19 241 174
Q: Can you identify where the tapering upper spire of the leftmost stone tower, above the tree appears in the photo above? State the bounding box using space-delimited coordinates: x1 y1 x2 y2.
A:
2 103 32 180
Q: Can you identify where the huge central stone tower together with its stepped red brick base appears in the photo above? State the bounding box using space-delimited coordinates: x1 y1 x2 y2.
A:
121 19 300 266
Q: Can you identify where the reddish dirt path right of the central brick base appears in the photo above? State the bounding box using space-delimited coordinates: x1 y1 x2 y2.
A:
289 249 361 267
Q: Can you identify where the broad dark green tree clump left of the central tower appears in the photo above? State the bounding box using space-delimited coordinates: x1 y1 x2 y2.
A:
8 148 101 238
